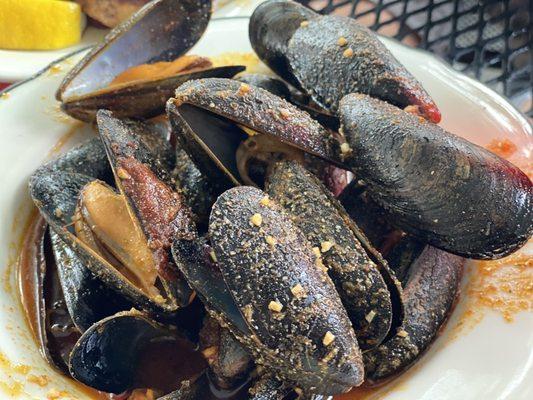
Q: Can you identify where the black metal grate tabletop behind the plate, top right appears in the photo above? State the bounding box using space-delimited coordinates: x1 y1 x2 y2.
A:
300 0 533 116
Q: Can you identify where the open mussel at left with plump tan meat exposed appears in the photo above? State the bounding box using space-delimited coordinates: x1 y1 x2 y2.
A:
30 114 194 322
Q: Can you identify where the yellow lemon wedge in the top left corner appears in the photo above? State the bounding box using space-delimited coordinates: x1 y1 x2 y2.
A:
0 0 85 50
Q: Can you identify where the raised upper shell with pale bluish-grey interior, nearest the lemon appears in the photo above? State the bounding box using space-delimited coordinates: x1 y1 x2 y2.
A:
56 0 211 102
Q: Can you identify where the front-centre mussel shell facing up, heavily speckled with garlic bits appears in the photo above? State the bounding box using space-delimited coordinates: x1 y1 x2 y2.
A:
209 186 363 394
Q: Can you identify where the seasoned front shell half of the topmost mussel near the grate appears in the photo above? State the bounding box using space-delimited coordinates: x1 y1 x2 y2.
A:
287 16 440 122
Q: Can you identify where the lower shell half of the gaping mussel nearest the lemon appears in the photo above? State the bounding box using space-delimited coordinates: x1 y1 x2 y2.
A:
61 66 244 121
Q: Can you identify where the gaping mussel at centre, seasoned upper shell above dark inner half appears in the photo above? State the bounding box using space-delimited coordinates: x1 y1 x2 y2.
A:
167 78 338 191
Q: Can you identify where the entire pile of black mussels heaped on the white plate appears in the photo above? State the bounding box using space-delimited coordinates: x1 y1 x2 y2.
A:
26 0 533 400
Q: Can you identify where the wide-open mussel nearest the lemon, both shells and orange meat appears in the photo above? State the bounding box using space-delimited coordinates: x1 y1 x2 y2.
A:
56 0 244 121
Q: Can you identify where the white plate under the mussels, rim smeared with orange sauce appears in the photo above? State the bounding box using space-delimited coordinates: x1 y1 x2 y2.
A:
0 13 533 400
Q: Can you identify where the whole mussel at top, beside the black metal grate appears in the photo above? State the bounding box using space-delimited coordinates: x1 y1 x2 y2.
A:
249 0 440 122
